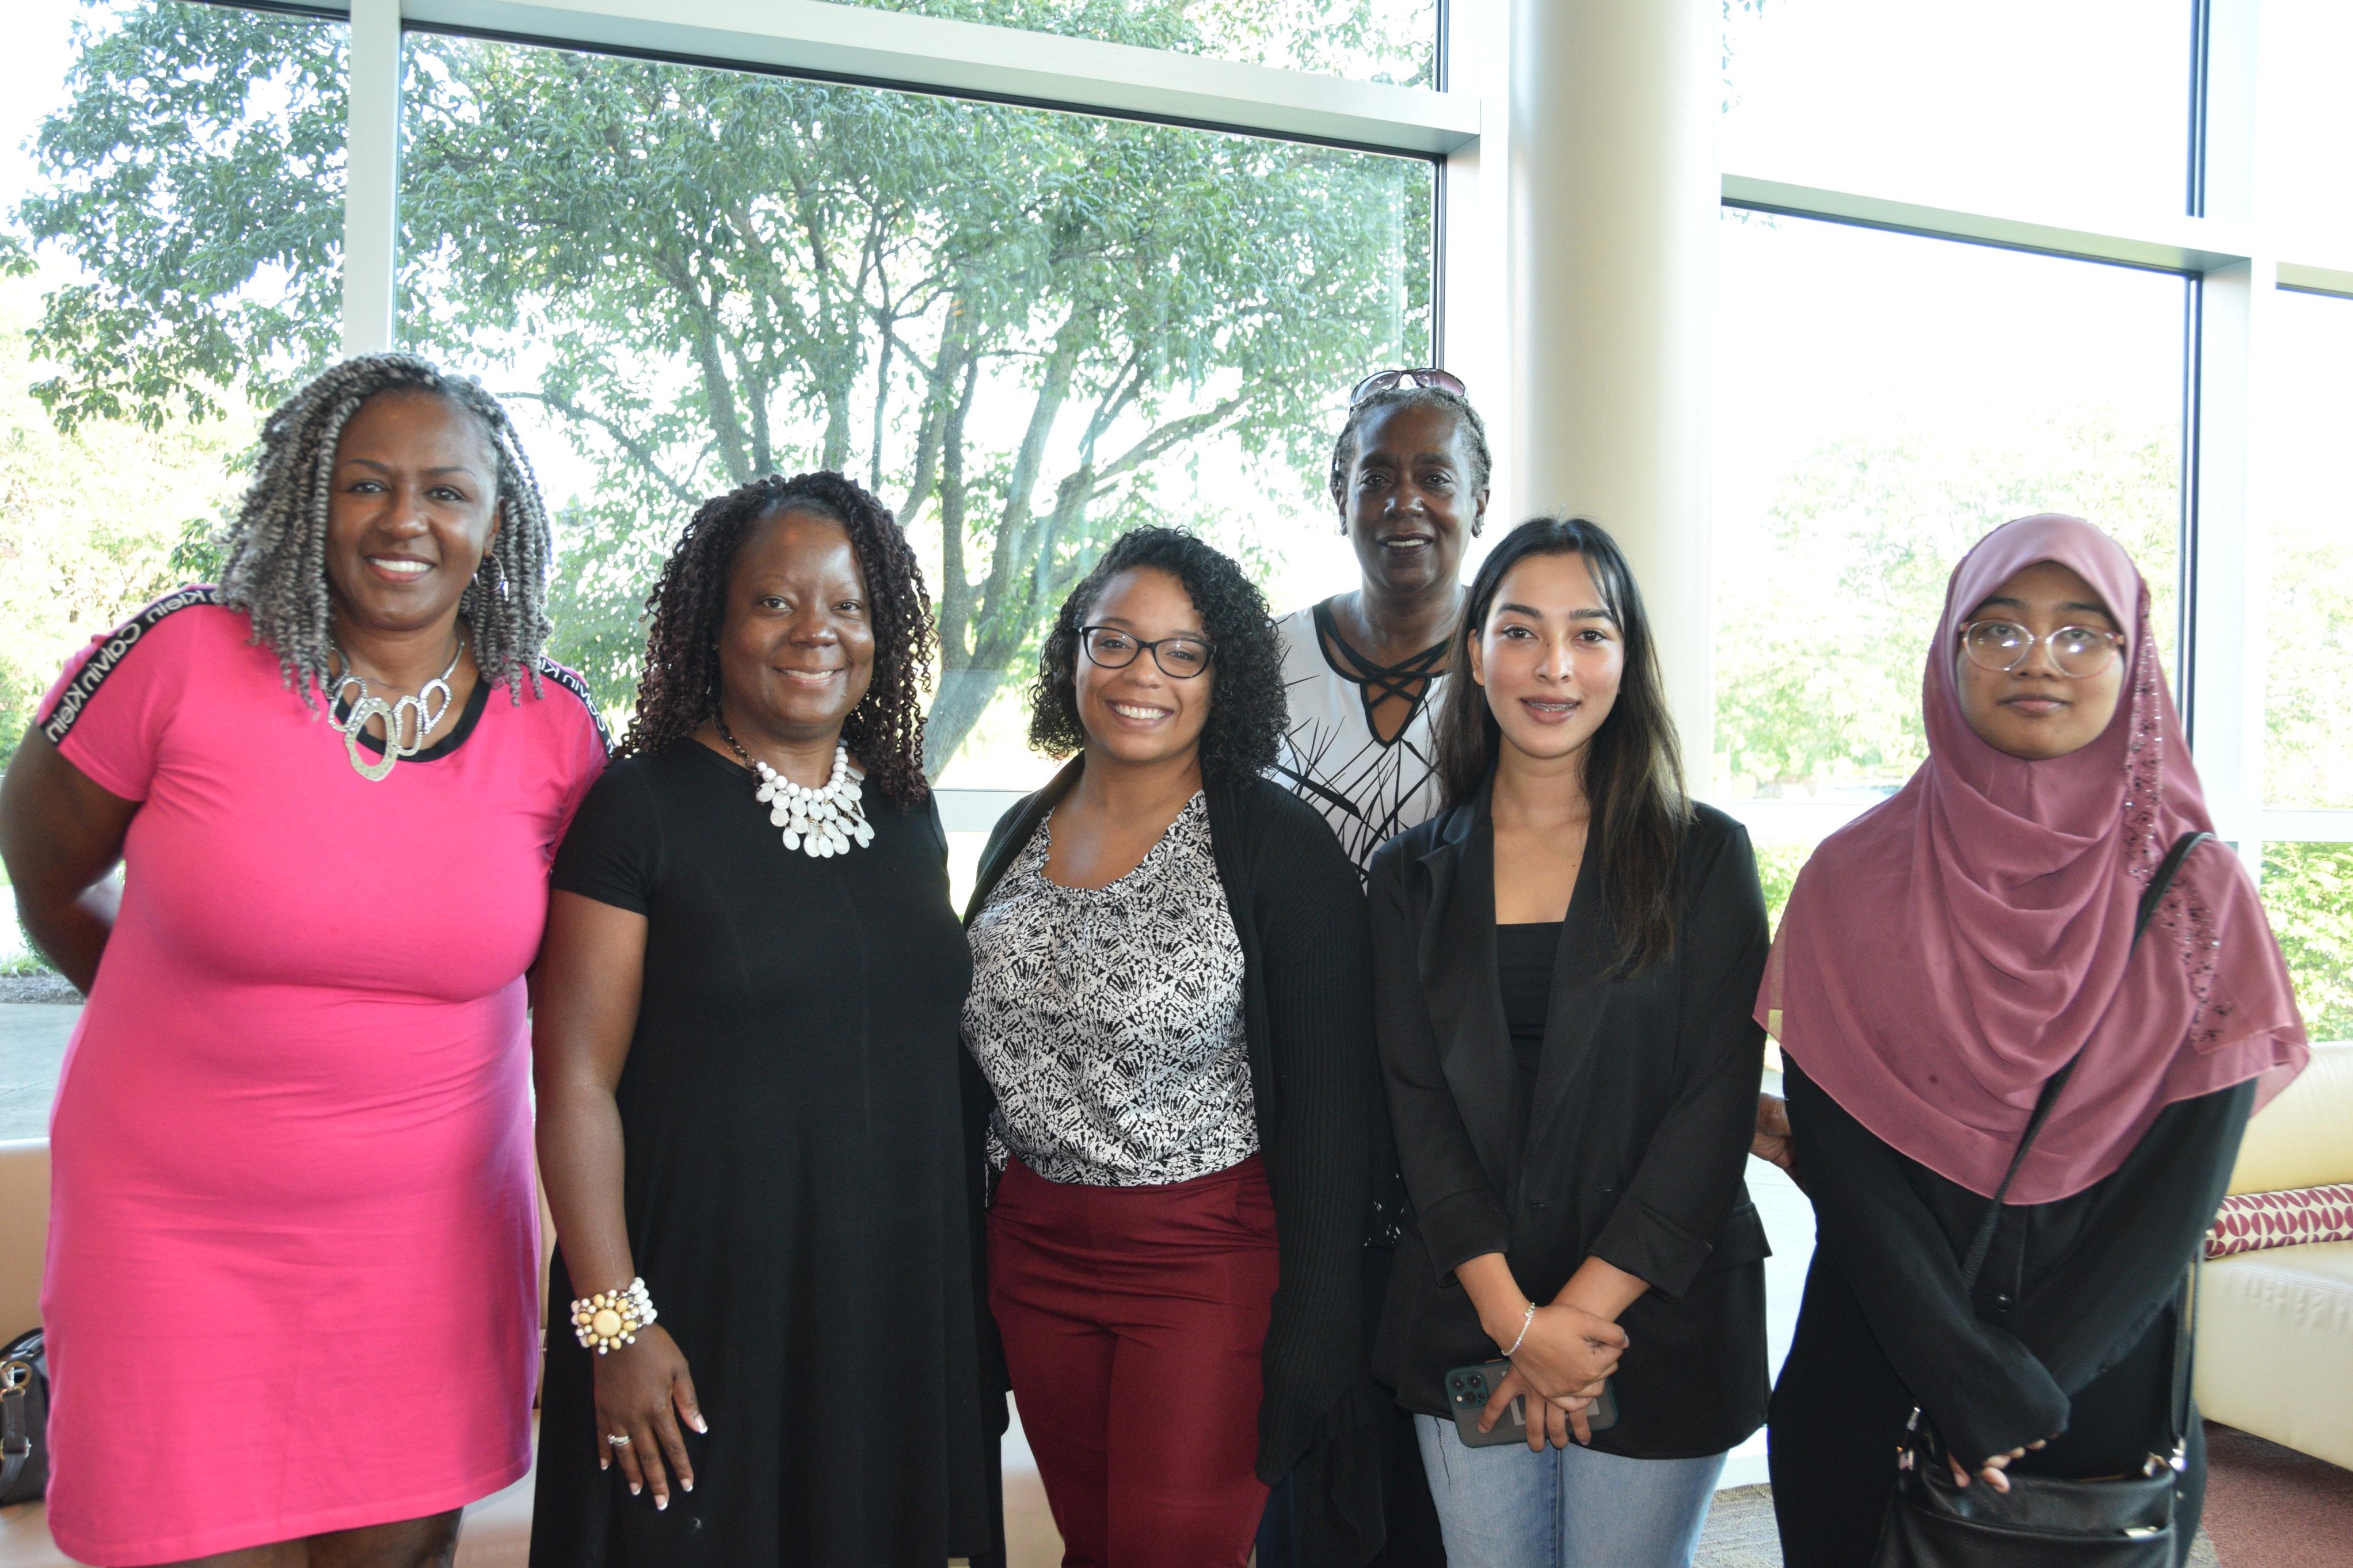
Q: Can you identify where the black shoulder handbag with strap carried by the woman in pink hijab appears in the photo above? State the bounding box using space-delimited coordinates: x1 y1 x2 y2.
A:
1871 832 2214 1568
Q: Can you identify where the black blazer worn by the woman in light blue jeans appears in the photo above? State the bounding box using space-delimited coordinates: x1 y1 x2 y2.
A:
1372 785 1769 1460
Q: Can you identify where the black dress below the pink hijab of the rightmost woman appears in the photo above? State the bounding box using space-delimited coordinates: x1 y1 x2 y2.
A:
1769 1063 2254 1568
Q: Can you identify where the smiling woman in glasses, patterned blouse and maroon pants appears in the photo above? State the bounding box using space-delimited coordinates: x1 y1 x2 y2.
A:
965 529 1376 1568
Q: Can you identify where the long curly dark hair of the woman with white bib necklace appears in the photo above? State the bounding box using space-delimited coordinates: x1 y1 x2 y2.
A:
616 470 939 806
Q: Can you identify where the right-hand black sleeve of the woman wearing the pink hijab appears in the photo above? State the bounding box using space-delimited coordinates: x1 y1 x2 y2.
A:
2009 1079 2254 1394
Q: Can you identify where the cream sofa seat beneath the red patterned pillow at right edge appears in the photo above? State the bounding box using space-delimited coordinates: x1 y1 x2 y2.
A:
2198 1241 2353 1469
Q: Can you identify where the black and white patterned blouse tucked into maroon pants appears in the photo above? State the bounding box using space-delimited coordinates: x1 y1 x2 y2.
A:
965 795 1259 1187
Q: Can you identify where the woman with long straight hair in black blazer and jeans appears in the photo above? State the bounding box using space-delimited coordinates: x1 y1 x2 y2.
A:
1372 520 1767 1568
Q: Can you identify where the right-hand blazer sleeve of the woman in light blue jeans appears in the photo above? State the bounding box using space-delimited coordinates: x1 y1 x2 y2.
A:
1593 823 1772 1300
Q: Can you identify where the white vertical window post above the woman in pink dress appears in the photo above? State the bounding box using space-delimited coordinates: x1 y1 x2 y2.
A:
344 0 400 355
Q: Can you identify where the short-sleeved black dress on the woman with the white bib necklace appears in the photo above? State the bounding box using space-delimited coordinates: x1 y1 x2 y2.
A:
532 741 995 1568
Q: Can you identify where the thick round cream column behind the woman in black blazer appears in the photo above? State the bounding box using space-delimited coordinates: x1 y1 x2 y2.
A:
1508 0 1720 792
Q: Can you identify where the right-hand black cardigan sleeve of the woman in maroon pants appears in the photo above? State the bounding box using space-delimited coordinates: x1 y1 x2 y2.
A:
1250 785 1372 1474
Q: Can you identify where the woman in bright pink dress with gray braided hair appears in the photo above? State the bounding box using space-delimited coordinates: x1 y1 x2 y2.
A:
0 355 605 1568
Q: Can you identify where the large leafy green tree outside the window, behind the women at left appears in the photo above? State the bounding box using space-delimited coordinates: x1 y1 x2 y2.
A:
19 0 1431 771
